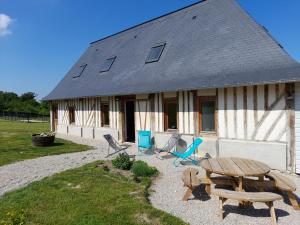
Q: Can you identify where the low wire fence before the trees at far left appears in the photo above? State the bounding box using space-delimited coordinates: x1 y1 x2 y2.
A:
0 110 50 123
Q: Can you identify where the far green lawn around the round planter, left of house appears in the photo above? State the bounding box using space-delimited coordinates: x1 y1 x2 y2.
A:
0 120 90 166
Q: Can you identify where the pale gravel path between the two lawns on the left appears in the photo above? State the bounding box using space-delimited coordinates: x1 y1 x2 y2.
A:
0 136 105 196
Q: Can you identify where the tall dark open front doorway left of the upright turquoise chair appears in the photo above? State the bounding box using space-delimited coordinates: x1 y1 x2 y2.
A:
125 100 135 142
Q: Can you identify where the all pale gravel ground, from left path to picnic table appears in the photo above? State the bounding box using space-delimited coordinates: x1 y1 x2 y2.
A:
0 135 300 225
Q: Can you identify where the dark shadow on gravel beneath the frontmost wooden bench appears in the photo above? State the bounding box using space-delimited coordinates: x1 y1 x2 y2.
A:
224 205 289 218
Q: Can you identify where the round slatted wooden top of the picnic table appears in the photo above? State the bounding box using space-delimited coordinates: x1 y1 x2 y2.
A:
200 158 270 177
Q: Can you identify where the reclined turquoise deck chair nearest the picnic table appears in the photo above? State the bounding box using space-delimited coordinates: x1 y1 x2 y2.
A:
172 138 203 167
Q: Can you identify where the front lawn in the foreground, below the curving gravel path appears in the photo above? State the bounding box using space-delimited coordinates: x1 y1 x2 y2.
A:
0 162 185 225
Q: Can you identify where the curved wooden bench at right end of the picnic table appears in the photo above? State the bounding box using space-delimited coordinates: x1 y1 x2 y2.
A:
266 170 300 210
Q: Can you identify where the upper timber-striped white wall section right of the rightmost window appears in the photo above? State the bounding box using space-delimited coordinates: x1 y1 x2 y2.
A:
218 84 287 142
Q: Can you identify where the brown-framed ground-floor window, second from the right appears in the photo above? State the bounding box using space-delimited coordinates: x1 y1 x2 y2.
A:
164 98 177 131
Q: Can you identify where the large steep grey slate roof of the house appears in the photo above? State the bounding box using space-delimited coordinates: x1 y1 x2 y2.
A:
44 0 300 100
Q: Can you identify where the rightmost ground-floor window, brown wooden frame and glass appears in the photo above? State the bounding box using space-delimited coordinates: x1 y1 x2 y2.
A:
199 97 216 132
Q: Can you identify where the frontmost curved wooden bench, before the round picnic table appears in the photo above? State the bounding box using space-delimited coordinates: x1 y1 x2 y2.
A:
212 189 282 224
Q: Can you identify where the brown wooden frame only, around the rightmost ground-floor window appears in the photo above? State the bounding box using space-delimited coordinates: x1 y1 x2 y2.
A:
197 96 218 135
